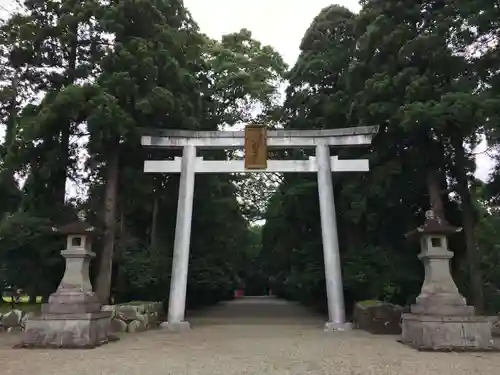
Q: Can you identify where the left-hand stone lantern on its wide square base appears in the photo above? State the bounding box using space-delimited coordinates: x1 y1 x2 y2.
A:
21 221 111 348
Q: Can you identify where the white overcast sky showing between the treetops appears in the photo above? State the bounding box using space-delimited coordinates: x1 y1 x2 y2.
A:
0 0 492 179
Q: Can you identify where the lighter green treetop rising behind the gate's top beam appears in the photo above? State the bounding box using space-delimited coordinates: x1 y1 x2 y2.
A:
202 29 287 126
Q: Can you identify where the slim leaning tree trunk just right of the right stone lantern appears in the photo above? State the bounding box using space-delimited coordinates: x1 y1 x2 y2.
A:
453 136 484 313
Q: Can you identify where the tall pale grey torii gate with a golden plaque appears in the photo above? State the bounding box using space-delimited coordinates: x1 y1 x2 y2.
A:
141 126 378 331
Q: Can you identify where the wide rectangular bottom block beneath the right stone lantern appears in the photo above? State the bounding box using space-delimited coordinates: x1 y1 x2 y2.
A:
401 314 494 351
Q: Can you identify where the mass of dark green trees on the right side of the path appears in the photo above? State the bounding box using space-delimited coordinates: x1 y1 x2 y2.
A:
263 0 498 314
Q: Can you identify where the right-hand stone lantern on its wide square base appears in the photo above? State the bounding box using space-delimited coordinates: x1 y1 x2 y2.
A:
401 211 493 350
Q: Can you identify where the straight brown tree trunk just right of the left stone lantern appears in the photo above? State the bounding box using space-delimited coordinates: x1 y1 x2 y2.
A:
96 142 119 304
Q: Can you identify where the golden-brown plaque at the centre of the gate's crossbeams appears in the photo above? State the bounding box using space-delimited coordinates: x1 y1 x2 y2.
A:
245 125 267 169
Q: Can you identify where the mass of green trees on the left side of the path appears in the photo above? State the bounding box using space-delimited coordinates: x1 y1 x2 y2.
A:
0 0 286 306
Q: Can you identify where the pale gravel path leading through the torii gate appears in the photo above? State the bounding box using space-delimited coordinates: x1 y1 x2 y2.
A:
0 298 500 375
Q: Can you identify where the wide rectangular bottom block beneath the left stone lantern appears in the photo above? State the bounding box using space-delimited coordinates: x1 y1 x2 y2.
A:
19 311 111 349
